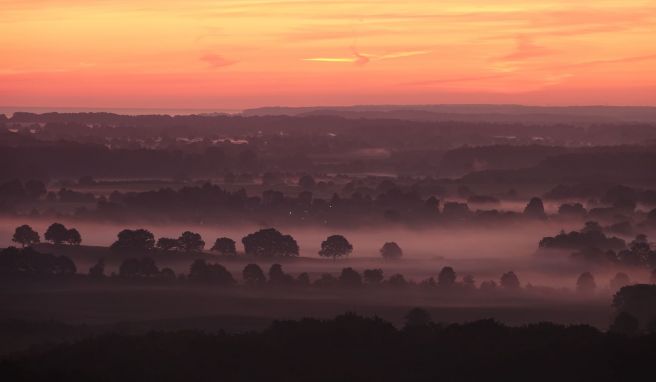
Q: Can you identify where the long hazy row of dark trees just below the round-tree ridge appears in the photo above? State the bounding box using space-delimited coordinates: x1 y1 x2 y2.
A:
0 247 656 295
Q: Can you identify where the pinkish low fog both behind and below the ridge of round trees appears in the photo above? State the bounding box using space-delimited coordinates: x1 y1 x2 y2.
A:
0 219 649 288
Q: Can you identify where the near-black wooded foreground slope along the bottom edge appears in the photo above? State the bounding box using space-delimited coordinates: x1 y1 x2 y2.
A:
0 314 656 382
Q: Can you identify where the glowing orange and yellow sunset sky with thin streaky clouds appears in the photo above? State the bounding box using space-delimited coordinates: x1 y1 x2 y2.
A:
0 0 656 110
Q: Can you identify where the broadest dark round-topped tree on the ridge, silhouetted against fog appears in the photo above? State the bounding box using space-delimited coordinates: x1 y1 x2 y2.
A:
241 228 299 257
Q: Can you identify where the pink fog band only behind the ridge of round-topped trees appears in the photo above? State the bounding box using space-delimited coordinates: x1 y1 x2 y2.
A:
0 218 579 259
